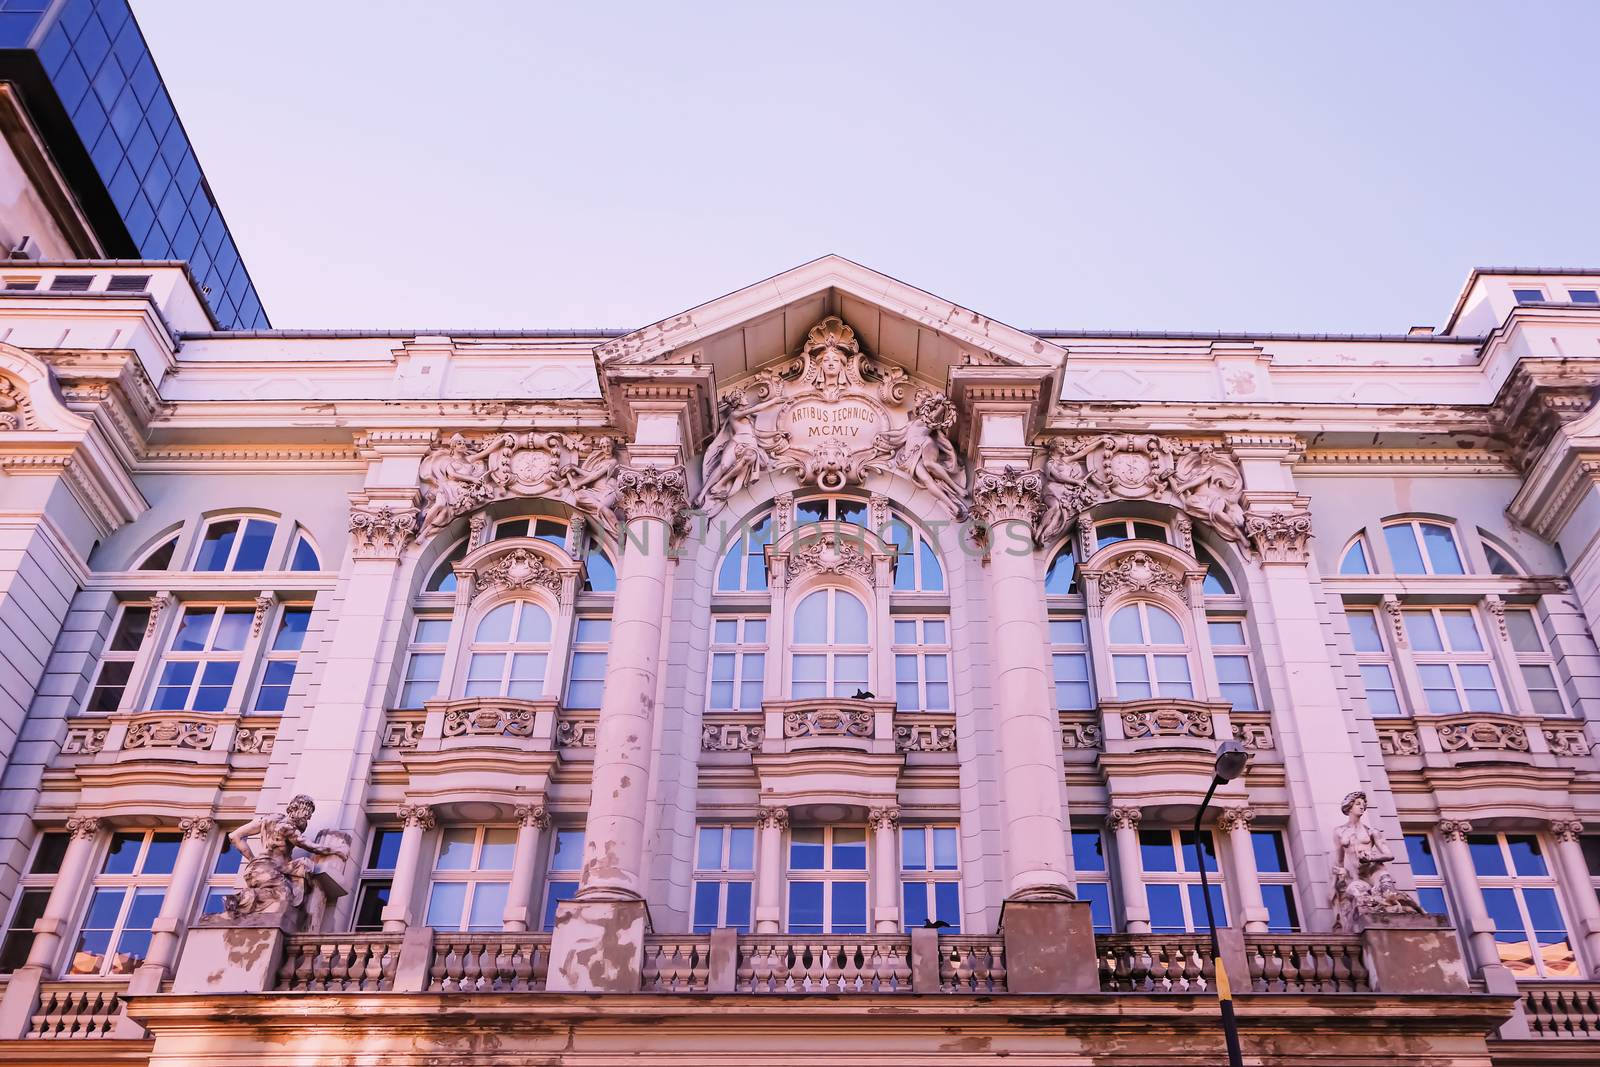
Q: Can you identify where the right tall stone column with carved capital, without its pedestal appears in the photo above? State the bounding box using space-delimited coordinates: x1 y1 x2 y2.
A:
973 466 1072 901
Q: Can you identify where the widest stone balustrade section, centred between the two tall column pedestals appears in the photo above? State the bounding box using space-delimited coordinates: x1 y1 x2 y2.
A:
734 934 912 993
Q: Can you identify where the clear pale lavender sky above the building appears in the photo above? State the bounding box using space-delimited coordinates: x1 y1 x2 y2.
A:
133 0 1600 333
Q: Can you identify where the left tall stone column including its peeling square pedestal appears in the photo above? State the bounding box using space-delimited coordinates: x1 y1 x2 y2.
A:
549 466 688 992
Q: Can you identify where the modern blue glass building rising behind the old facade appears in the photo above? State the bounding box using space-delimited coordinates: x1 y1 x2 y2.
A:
0 0 270 330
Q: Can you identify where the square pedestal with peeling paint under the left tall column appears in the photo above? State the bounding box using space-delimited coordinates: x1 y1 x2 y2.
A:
544 901 650 993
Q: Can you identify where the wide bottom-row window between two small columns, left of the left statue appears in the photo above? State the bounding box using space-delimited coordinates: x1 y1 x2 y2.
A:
67 830 182 974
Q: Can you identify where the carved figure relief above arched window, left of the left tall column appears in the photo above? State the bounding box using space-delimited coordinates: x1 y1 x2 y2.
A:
419 430 619 537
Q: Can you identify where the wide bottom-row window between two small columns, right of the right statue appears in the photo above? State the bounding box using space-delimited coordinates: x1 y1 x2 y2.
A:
1467 833 1582 977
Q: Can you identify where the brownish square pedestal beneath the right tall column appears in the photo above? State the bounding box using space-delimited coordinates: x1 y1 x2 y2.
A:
1000 897 1099 993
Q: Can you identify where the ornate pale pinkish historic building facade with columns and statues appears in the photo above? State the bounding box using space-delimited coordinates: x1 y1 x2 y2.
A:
0 258 1600 1065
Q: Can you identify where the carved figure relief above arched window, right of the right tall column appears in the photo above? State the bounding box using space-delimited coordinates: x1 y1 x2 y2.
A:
1038 434 1245 544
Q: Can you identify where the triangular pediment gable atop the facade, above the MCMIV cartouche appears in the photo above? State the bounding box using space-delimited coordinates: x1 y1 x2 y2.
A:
597 256 1066 386
